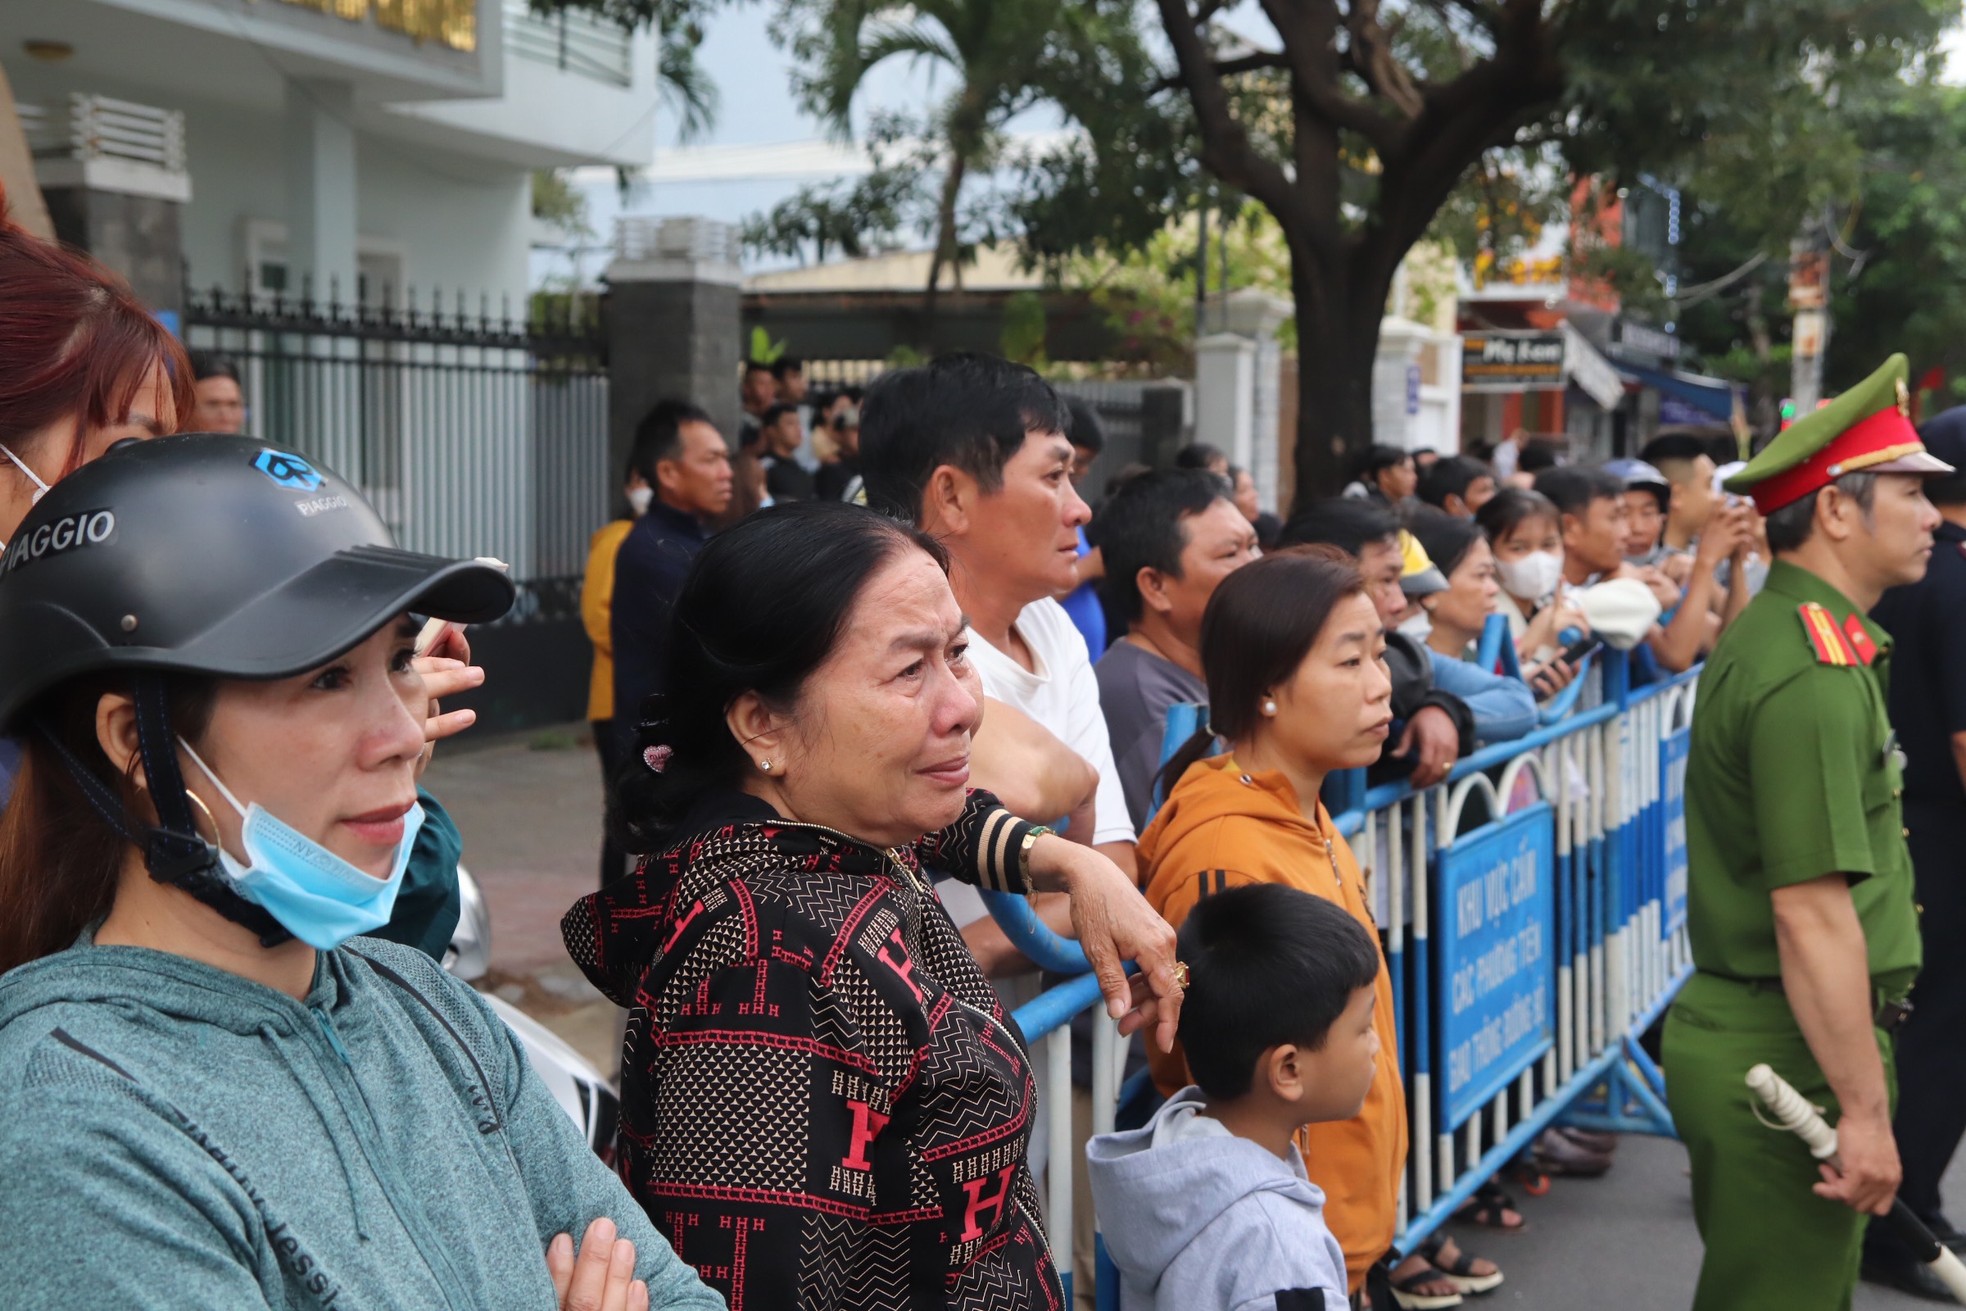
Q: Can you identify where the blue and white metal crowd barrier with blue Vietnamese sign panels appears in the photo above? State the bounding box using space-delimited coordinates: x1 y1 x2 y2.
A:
989 636 1699 1307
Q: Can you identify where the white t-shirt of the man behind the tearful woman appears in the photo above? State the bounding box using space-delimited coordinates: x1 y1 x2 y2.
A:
969 599 1134 843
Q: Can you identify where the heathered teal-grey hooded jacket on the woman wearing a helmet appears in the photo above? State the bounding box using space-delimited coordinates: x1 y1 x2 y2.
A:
0 936 723 1311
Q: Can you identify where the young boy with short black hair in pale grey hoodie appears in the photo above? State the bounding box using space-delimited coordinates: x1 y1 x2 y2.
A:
1085 884 1378 1311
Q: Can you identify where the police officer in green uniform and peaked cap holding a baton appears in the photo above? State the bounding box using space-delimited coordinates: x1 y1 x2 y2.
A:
1665 356 1952 1311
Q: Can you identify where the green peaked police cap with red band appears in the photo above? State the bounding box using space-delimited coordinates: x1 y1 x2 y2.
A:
1726 356 1954 515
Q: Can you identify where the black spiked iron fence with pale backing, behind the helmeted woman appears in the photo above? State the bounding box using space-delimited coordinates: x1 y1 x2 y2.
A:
185 291 619 621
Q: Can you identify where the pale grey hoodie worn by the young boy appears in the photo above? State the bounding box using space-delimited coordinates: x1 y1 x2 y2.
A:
1085 1087 1347 1311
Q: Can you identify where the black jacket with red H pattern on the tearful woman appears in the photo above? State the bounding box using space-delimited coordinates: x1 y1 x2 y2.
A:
560 792 1064 1311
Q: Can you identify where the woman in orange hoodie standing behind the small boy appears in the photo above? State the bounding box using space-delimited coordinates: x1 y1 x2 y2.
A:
1140 546 1502 1309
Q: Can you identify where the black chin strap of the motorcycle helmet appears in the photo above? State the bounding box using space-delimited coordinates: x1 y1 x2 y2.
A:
39 670 293 947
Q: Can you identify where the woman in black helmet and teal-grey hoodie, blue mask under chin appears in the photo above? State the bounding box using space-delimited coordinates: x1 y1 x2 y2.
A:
0 434 722 1311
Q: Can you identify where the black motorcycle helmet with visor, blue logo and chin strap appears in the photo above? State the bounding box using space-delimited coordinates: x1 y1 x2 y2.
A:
0 432 513 943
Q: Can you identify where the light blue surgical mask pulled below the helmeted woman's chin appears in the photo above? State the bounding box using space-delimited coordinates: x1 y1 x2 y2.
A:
177 739 423 951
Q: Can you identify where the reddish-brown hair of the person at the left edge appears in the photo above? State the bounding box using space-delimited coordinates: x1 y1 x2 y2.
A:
0 189 197 471
